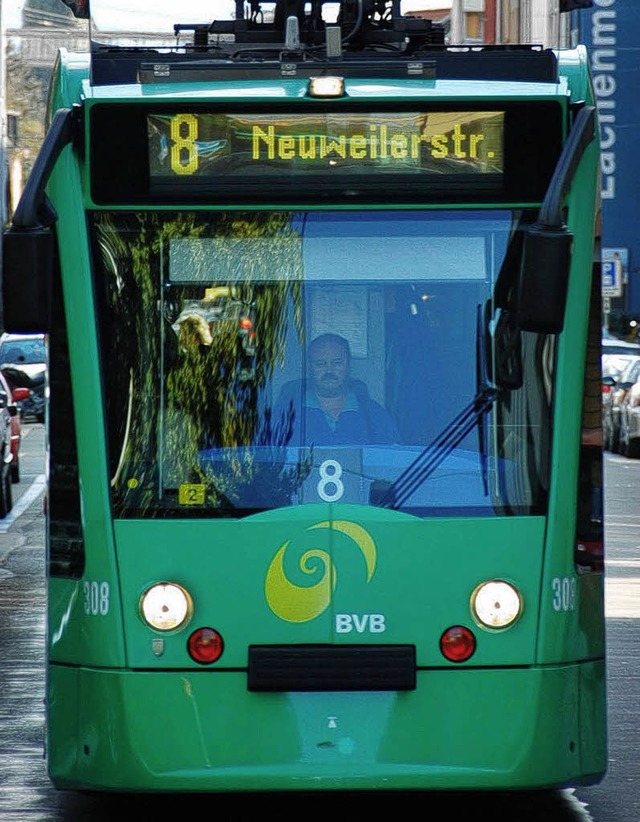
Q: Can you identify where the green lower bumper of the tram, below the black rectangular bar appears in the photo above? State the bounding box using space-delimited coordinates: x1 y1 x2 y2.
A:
48 661 606 792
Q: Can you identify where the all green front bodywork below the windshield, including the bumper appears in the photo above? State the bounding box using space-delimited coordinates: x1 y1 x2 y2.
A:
48 506 606 791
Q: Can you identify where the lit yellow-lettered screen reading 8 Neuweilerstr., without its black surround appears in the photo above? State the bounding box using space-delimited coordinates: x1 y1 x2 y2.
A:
147 111 504 182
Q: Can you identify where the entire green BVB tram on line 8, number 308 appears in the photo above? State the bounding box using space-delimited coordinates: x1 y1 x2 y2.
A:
3 0 607 792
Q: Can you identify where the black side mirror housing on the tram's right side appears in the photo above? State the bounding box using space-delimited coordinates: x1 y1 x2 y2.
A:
515 224 573 334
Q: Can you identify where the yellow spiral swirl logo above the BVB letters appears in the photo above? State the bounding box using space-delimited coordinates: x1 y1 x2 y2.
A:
264 520 376 622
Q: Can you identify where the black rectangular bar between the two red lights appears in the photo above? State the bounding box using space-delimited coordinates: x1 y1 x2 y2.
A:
247 645 416 691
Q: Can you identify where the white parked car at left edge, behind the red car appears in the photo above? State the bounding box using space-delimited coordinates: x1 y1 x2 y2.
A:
0 334 47 422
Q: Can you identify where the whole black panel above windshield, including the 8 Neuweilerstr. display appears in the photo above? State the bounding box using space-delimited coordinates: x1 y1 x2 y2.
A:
88 100 566 206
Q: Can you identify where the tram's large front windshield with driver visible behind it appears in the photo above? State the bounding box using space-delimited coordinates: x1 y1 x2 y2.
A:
92 210 554 517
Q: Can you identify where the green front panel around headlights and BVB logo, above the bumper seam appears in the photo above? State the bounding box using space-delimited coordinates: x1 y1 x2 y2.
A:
50 516 603 669
